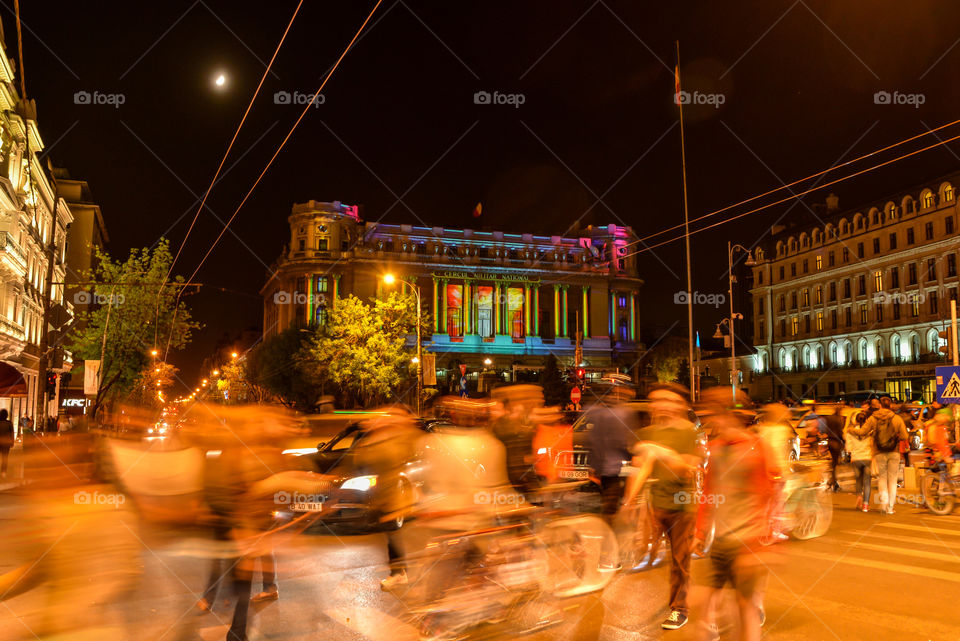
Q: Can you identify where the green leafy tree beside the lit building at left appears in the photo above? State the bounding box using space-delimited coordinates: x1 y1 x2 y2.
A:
67 239 200 417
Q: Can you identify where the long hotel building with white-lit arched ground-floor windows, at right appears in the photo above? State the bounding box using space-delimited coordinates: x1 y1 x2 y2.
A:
751 173 960 401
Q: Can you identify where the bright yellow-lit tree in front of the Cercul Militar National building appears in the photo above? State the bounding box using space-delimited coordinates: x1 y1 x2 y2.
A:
298 292 416 406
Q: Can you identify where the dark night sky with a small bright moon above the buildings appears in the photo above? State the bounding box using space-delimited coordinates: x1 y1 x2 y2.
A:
11 0 960 383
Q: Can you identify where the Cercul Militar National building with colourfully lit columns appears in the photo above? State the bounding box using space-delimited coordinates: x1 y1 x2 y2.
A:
261 201 643 378
